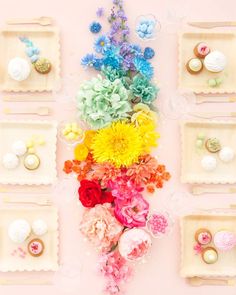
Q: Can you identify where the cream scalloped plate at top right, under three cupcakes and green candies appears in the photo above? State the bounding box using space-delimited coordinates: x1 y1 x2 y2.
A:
178 31 236 94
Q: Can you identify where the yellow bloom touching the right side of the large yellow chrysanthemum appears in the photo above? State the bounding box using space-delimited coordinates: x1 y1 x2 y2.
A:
137 124 160 153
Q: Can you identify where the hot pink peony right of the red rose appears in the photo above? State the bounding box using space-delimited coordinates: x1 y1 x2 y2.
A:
115 195 149 228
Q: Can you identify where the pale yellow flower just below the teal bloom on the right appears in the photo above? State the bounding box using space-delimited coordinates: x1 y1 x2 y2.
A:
131 103 156 126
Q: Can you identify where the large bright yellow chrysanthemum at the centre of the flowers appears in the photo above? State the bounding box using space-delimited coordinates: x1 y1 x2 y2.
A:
92 121 143 167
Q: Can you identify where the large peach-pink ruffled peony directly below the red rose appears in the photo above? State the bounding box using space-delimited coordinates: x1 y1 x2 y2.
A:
80 203 123 251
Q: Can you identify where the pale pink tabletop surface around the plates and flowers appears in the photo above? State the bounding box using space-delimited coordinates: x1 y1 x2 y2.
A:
0 0 236 295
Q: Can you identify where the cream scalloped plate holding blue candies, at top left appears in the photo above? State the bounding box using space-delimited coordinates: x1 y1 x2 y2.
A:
0 26 60 92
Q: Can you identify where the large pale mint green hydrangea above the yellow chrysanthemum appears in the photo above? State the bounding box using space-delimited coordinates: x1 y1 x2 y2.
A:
77 76 132 129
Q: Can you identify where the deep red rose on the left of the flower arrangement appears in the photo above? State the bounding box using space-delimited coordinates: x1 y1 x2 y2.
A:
78 179 114 208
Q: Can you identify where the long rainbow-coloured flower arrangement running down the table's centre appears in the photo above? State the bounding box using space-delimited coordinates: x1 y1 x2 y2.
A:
64 0 170 295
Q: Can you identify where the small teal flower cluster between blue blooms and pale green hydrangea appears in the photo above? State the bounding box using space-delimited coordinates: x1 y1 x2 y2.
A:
102 66 131 89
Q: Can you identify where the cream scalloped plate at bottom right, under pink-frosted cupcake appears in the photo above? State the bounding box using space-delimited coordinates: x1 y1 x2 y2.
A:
180 213 236 278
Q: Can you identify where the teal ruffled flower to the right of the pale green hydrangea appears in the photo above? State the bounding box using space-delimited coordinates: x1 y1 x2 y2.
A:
130 75 159 104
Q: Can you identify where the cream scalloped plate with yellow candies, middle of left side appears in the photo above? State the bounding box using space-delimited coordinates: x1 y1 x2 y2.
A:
0 120 57 185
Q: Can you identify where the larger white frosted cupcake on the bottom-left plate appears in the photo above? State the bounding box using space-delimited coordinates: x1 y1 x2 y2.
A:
8 219 31 244
